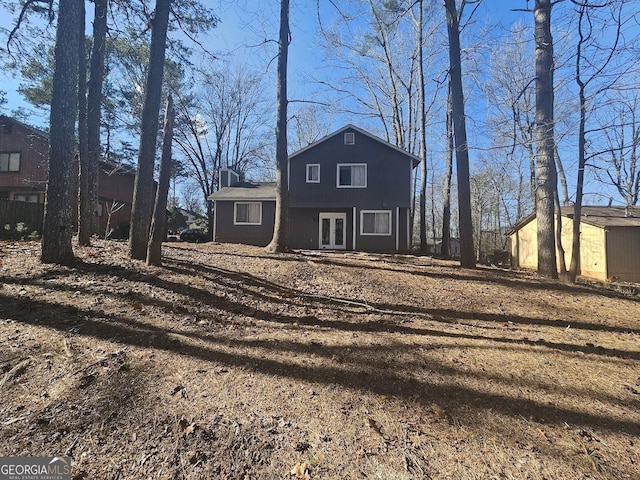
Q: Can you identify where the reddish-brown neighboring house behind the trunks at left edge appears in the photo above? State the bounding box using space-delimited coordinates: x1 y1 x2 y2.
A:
0 115 136 233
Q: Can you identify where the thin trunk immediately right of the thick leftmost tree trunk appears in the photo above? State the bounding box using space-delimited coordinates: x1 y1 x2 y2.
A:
77 2 91 245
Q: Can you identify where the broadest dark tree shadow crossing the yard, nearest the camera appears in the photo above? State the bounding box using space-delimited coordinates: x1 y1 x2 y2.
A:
0 292 640 435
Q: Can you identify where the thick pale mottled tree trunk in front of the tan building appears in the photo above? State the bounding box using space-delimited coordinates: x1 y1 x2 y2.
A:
534 0 558 278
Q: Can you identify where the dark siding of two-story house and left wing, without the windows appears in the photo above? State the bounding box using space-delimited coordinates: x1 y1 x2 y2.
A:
210 126 417 252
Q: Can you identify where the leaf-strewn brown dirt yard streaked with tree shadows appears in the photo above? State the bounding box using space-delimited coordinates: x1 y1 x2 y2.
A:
0 241 640 480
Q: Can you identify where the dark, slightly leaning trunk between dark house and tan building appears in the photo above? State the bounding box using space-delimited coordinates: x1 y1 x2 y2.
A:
444 0 476 268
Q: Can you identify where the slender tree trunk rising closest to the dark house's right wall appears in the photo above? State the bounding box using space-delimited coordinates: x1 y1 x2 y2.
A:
416 0 428 252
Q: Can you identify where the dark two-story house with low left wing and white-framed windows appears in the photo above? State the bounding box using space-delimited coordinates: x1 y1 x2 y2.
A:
209 125 419 252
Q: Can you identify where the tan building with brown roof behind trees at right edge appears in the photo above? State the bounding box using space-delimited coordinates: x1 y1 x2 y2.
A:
508 206 640 282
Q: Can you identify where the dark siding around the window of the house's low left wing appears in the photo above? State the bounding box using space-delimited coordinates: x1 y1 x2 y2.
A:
214 200 276 247
